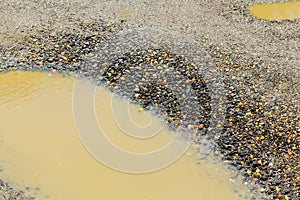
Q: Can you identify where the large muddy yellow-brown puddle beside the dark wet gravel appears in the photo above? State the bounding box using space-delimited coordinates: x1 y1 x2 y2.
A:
0 72 246 200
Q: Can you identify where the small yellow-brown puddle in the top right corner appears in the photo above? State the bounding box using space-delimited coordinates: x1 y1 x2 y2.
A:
248 1 300 21
